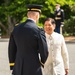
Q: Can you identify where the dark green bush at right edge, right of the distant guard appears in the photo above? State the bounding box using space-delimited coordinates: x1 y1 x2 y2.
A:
64 16 75 36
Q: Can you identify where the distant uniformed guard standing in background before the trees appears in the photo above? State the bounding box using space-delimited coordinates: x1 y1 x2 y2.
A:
54 4 64 33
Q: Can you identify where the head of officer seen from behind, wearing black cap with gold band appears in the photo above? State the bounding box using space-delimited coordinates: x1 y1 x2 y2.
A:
27 4 43 22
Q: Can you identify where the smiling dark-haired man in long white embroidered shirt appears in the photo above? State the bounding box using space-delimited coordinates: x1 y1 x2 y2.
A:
42 18 69 75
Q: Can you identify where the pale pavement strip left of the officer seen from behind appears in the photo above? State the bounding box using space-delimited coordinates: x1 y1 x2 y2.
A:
0 40 11 75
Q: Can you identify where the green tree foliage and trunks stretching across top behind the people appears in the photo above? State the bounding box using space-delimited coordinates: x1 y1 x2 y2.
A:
0 0 75 35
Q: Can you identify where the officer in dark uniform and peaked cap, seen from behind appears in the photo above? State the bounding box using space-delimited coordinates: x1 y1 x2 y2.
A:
8 4 48 75
